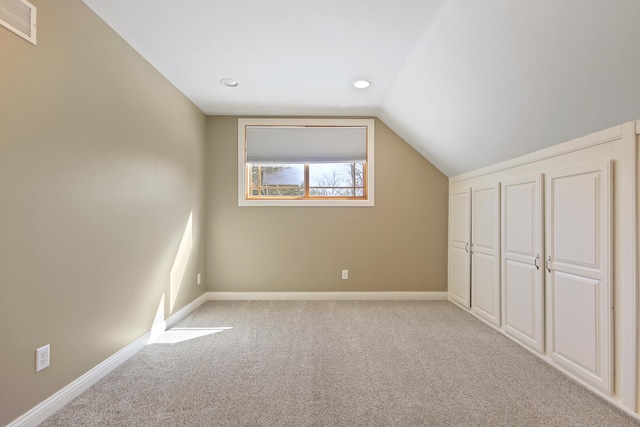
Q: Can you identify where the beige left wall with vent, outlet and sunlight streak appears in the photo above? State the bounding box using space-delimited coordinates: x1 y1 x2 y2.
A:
0 0 206 425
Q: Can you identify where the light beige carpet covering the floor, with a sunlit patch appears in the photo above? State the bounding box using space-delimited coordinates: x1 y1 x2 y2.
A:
42 301 640 426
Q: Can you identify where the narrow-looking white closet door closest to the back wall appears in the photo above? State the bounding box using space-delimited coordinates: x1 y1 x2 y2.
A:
449 188 471 308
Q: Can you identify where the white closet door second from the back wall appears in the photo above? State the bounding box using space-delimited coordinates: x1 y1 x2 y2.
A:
471 184 500 326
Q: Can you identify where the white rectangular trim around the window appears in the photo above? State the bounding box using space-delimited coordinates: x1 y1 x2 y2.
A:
238 118 375 207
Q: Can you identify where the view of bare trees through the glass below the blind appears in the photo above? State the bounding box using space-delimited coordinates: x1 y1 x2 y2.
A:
249 163 365 198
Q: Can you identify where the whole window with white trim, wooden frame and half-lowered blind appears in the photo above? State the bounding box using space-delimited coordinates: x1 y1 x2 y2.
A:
238 119 374 206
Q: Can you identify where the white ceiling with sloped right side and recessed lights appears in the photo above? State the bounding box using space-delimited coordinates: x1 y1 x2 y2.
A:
84 0 640 176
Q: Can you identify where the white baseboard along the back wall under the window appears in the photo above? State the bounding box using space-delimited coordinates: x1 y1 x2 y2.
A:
205 291 448 301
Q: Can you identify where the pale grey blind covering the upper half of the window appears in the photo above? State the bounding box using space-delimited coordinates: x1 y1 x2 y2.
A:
246 126 367 164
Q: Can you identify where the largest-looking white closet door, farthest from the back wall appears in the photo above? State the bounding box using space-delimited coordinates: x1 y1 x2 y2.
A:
545 162 613 393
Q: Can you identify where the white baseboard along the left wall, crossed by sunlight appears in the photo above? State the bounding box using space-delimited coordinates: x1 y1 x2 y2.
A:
7 294 208 427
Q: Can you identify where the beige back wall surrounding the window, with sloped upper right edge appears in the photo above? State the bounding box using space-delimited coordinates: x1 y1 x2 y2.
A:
206 117 448 292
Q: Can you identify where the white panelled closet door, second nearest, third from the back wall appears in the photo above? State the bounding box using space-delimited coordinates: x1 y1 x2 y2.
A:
501 175 544 353
